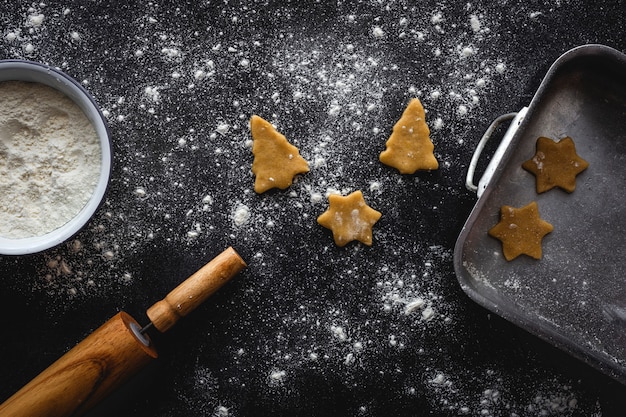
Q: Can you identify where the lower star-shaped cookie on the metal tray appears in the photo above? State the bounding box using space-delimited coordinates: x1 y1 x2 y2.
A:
488 201 553 261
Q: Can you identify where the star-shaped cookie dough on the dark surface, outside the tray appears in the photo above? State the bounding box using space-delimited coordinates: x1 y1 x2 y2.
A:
317 191 381 246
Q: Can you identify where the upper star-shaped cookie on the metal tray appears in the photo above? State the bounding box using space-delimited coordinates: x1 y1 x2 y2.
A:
522 137 589 193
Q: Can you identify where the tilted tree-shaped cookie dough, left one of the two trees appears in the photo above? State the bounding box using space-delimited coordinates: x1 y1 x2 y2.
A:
250 115 309 194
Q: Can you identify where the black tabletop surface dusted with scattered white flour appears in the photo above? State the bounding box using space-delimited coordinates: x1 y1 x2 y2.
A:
0 0 626 416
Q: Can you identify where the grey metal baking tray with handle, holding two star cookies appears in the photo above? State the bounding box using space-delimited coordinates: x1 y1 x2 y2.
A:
454 45 626 383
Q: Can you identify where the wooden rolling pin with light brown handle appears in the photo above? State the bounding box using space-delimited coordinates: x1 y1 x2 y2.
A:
0 248 246 417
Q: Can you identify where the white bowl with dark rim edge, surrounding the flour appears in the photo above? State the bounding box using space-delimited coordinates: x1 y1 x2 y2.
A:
0 60 111 255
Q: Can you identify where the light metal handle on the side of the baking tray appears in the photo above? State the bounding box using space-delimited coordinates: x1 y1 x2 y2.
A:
465 107 528 198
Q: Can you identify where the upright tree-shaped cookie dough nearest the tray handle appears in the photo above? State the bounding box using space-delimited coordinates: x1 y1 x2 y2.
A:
380 98 439 174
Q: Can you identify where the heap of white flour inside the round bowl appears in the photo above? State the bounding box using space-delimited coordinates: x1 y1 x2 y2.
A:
0 81 101 239
